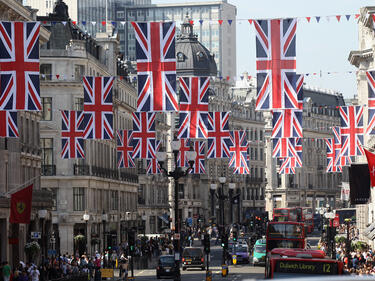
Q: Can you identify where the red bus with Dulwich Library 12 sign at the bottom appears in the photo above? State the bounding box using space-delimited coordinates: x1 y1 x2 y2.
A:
265 249 344 278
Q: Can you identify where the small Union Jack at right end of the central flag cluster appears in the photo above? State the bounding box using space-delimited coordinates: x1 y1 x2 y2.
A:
228 131 250 174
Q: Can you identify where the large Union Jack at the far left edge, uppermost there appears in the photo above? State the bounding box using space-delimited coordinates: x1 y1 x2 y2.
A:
0 21 42 110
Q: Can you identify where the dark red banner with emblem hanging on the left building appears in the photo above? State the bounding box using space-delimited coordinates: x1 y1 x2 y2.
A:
9 184 33 224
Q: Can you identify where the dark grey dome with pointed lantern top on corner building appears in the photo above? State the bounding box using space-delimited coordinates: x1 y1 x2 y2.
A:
176 15 217 76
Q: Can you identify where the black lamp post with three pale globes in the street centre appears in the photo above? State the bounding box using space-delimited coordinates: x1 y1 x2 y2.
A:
156 137 197 280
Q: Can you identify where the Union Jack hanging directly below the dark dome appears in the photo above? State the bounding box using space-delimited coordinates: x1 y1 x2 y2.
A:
178 77 210 139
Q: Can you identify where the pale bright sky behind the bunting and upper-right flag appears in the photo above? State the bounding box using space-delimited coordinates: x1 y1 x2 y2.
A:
152 0 375 98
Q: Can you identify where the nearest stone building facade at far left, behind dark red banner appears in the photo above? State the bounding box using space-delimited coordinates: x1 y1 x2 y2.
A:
0 0 51 264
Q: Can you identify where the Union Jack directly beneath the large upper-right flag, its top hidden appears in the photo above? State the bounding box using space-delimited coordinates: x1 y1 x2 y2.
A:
271 109 303 138
